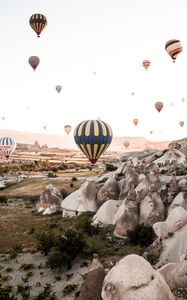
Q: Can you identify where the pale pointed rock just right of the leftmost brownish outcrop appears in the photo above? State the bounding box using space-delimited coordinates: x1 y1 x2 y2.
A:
61 181 97 217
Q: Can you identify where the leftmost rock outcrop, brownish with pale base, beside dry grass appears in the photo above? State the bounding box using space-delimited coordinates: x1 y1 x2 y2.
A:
36 184 63 215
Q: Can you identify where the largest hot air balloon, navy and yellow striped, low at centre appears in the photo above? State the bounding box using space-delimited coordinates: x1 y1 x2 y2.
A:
74 120 113 164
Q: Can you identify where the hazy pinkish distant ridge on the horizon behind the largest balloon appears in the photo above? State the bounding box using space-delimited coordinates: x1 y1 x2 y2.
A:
0 130 170 152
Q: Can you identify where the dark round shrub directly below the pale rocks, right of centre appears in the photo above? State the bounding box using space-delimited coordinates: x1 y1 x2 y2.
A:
127 224 154 247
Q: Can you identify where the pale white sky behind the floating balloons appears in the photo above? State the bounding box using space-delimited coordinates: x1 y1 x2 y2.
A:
0 0 187 140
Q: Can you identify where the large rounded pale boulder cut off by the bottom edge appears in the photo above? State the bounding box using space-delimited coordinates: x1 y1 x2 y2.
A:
101 254 174 300
